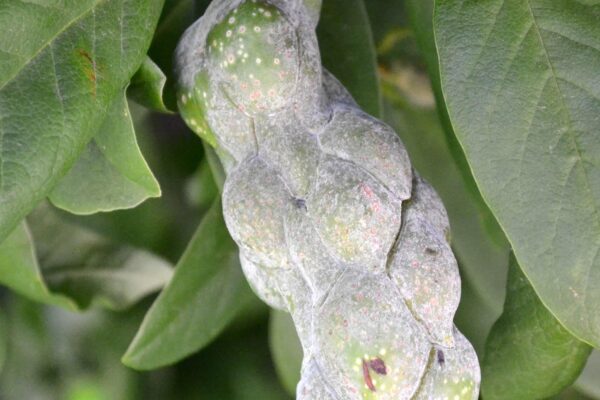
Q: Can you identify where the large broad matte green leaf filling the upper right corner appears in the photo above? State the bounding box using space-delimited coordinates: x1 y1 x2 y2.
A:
435 0 600 347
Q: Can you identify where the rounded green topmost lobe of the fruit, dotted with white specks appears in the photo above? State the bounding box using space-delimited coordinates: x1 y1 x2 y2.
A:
206 1 299 113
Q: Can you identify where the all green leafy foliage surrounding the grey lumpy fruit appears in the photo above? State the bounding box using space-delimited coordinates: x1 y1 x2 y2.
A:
0 0 600 400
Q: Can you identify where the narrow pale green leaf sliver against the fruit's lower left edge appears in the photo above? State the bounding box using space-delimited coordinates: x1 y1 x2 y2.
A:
269 310 303 395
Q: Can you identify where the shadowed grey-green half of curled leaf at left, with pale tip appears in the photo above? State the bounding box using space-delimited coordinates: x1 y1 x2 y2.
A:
28 207 172 310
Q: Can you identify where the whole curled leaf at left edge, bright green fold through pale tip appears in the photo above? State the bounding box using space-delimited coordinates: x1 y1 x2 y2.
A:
0 205 172 310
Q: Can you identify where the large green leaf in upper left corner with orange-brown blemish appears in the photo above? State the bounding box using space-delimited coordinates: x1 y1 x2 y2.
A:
0 0 162 241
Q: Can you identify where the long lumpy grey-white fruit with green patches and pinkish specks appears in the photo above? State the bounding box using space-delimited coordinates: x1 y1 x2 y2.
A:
177 0 480 400
